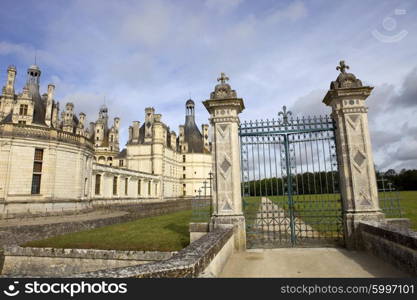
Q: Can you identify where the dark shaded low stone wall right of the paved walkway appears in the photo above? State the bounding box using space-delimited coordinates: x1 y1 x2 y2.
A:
359 222 417 276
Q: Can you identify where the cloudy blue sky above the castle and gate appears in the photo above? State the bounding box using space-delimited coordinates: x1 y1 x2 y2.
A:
0 0 417 170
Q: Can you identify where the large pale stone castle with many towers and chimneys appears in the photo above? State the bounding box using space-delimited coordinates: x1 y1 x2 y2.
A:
0 65 212 217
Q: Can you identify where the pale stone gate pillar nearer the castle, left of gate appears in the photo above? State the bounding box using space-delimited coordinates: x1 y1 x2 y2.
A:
203 73 246 251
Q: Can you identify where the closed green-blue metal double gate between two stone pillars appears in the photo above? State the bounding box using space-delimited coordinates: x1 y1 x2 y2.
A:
239 106 343 248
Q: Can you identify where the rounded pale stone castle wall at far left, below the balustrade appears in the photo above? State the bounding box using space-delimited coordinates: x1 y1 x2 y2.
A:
0 124 93 215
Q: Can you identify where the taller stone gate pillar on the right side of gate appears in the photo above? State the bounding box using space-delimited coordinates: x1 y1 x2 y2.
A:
323 61 384 248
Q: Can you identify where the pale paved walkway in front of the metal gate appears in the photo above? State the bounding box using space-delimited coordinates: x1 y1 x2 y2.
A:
219 248 410 278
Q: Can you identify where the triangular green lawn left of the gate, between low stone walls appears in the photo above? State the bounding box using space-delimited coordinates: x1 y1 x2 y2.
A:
23 210 191 251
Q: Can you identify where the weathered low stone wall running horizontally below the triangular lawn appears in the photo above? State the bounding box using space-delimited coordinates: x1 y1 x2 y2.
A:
2 246 176 277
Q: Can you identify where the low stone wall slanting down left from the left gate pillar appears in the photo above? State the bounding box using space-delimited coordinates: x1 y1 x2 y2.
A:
74 226 234 278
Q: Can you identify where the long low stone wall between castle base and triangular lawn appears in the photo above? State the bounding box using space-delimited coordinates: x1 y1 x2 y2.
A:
0 199 191 248
